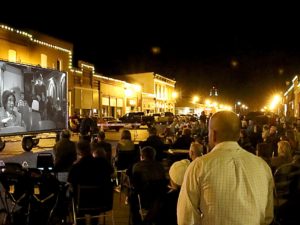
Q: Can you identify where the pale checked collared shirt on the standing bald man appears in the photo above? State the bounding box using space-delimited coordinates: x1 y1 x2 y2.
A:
177 142 274 225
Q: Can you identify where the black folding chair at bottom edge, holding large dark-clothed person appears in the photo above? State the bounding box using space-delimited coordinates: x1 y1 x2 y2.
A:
72 185 115 225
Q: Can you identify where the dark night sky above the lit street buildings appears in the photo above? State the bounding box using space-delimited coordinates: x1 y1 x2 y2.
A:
0 4 300 110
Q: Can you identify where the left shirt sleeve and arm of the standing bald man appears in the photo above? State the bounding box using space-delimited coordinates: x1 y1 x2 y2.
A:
177 160 203 225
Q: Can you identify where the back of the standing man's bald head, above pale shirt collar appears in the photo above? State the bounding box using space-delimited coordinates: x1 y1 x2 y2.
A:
209 111 240 148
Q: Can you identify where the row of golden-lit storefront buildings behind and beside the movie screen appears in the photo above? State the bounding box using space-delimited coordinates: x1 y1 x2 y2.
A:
0 24 176 117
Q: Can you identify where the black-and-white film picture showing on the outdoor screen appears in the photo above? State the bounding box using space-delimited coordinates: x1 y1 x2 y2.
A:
0 61 68 135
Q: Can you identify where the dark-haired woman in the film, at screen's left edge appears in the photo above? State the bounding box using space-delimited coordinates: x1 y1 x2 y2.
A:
0 90 25 127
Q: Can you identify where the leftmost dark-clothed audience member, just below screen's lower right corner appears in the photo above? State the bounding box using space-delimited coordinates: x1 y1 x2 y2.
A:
53 129 77 172
